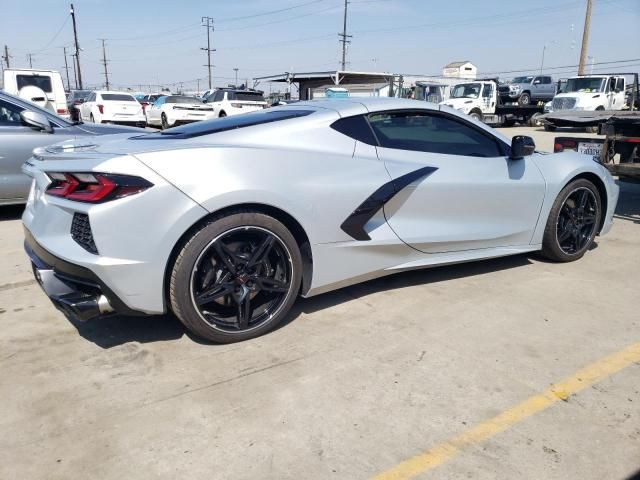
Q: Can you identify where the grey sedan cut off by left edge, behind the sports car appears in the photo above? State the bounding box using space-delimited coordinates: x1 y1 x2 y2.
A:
0 92 141 205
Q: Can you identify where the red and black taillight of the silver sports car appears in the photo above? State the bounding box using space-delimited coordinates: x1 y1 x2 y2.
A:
46 172 153 203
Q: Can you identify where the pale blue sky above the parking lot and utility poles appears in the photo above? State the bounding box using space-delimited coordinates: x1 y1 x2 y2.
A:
0 0 640 93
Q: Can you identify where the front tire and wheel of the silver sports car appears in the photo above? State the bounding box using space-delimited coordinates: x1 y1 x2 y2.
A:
542 178 602 262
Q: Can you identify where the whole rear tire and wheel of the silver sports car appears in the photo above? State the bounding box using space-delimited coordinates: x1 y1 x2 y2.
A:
169 210 302 343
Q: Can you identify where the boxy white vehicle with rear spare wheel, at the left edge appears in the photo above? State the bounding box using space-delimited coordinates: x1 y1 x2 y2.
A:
3 68 70 119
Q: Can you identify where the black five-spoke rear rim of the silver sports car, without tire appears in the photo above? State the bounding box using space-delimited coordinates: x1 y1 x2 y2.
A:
190 226 293 333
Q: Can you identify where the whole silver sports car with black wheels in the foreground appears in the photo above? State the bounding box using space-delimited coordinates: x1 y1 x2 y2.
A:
23 98 618 342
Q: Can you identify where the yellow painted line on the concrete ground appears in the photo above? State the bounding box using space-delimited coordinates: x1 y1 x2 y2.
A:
373 342 640 480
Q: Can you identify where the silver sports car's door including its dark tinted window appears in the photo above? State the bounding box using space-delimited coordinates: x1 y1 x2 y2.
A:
369 110 545 253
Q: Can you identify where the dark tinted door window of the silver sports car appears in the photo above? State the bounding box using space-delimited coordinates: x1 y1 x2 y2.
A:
369 111 503 157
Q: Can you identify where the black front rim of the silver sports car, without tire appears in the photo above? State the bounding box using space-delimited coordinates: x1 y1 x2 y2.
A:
556 187 598 255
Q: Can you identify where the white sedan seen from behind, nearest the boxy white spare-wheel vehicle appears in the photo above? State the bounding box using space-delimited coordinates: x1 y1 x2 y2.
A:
79 91 146 127
